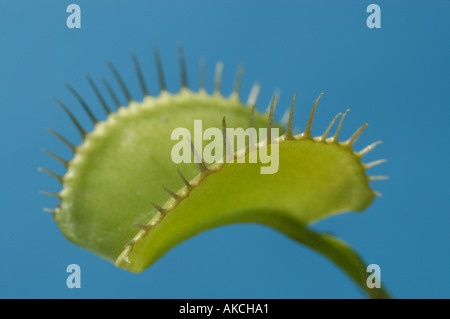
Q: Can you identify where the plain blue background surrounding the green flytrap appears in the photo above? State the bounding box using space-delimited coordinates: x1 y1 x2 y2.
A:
0 0 450 298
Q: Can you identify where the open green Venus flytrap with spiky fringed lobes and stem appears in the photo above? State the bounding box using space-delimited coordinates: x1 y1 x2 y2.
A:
41 45 389 298
